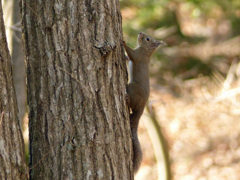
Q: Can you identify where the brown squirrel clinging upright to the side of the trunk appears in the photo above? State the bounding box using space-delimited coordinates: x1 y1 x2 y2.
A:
122 32 167 174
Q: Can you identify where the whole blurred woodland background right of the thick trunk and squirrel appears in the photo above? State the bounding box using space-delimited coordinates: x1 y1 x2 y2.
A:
120 0 240 180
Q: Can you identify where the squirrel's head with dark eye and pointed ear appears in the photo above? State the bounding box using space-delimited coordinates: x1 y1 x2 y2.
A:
138 32 167 54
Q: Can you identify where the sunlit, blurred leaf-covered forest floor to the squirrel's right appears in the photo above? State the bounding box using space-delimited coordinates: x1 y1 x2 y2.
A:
136 65 240 180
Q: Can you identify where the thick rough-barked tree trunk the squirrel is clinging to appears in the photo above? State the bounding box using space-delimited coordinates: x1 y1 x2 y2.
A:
21 0 133 180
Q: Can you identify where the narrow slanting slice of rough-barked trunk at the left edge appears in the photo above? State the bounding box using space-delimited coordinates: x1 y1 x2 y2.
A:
0 2 27 180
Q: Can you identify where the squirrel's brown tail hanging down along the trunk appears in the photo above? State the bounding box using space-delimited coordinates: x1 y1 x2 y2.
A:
130 109 144 174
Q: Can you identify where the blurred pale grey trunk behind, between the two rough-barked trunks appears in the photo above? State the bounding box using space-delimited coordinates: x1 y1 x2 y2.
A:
3 0 27 120
